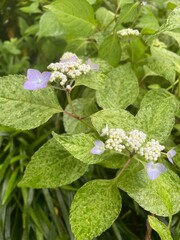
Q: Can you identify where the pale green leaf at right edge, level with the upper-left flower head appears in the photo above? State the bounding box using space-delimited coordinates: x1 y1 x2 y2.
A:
147 47 180 84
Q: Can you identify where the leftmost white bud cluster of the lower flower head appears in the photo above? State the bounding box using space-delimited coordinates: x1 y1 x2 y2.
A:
105 128 126 152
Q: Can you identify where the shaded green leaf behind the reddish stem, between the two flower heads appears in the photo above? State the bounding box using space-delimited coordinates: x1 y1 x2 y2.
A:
63 98 98 134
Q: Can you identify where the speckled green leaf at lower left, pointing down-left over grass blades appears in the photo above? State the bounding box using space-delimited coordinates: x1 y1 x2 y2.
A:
18 138 88 188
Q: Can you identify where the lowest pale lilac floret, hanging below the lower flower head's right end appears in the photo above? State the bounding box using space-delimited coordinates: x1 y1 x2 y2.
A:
146 162 167 180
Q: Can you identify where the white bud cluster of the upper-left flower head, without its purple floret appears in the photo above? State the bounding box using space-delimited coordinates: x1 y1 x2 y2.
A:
47 52 91 89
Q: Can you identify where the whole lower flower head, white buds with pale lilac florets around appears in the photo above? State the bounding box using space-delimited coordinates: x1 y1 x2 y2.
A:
91 124 169 180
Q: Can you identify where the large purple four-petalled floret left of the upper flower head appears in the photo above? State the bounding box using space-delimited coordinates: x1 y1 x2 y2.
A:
24 69 51 90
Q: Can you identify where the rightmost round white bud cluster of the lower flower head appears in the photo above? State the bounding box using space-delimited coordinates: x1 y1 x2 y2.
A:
139 139 165 161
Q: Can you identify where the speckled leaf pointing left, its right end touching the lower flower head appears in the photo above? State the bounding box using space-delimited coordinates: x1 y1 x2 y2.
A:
53 133 103 164
